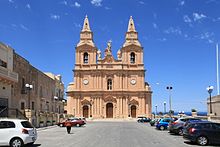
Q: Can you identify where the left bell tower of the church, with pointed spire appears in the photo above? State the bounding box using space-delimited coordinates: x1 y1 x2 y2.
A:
75 15 97 68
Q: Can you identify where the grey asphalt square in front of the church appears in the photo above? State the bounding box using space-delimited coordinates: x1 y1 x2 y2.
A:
33 122 218 147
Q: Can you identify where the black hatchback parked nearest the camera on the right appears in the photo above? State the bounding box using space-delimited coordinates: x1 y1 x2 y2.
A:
183 121 220 146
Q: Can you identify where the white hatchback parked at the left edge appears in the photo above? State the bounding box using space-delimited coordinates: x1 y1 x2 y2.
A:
0 118 37 147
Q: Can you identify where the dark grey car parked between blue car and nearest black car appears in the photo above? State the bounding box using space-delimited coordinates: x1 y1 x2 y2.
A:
169 117 201 135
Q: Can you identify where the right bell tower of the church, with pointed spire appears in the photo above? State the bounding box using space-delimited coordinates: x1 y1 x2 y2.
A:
121 16 143 65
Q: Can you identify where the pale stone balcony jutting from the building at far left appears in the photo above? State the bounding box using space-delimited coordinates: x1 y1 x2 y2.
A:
0 66 18 83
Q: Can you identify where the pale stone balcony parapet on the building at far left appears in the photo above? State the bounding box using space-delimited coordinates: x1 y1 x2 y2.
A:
0 66 18 82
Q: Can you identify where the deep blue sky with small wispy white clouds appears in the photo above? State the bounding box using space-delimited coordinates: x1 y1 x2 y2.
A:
0 0 220 111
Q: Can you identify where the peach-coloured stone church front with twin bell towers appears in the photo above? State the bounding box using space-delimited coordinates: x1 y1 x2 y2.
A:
67 16 152 119
